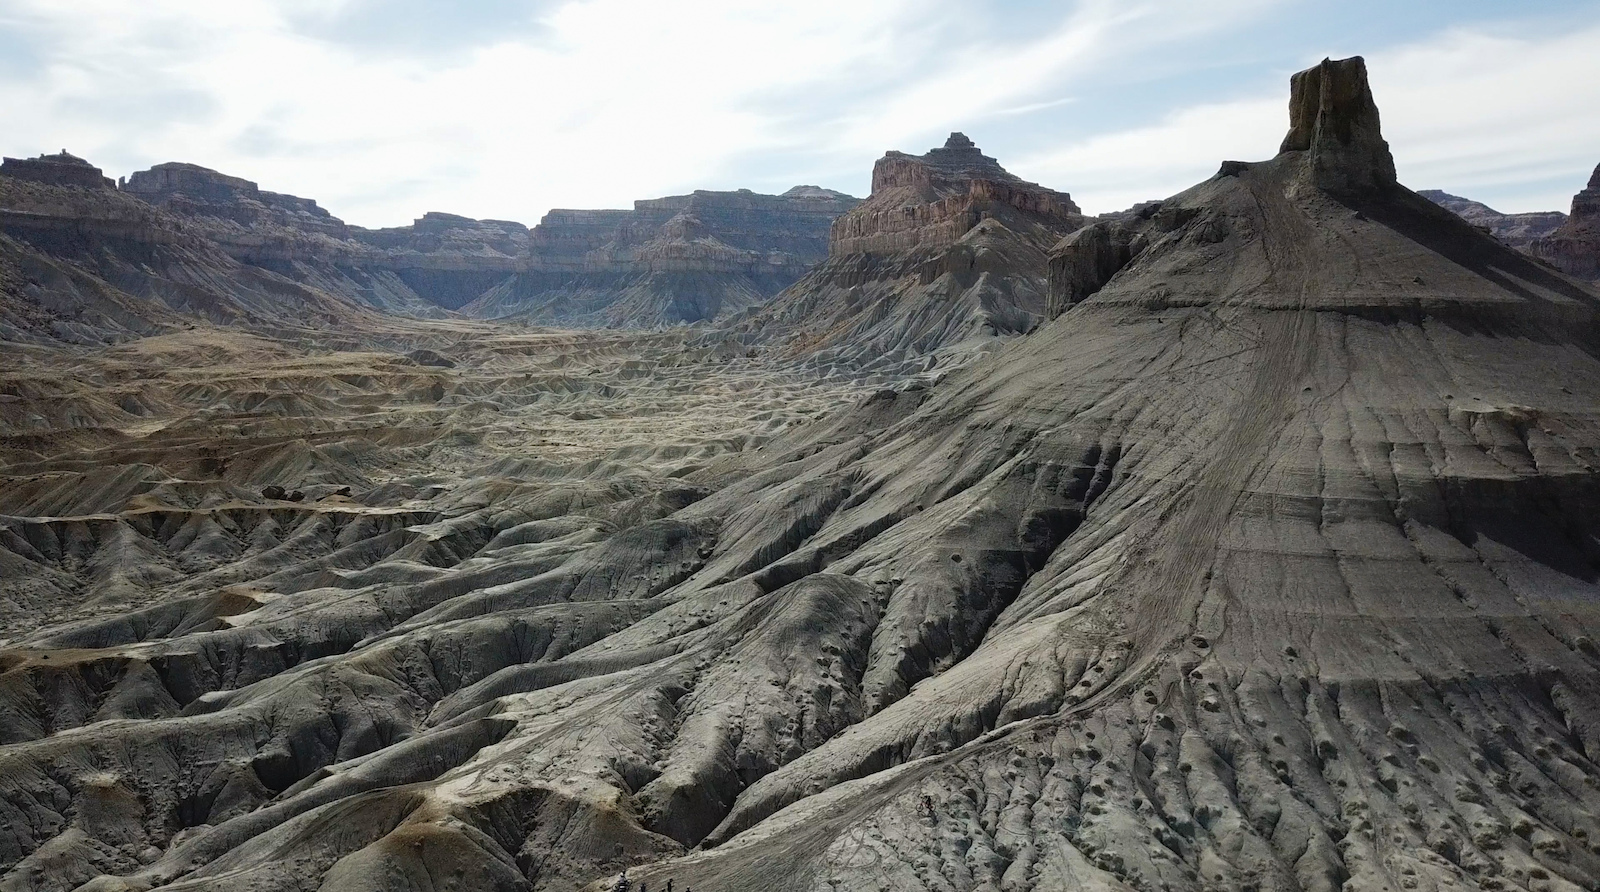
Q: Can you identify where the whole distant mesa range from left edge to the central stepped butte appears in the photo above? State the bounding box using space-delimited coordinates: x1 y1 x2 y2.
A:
0 152 858 339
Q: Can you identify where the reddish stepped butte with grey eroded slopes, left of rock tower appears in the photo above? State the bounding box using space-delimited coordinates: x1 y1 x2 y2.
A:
734 133 1086 371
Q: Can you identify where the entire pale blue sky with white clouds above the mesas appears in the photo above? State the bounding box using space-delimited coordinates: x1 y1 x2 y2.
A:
0 0 1600 225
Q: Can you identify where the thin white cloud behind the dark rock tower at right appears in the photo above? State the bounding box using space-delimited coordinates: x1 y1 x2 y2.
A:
1011 19 1600 213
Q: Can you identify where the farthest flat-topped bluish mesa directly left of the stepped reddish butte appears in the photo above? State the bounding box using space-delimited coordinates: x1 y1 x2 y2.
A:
464 185 859 328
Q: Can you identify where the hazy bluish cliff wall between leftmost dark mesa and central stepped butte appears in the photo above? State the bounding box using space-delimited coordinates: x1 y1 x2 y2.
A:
114 163 858 328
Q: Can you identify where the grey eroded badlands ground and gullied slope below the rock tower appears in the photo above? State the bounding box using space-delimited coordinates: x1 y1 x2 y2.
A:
9 169 1600 892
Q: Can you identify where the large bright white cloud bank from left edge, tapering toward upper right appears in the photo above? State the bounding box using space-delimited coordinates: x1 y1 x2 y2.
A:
0 0 1275 224
